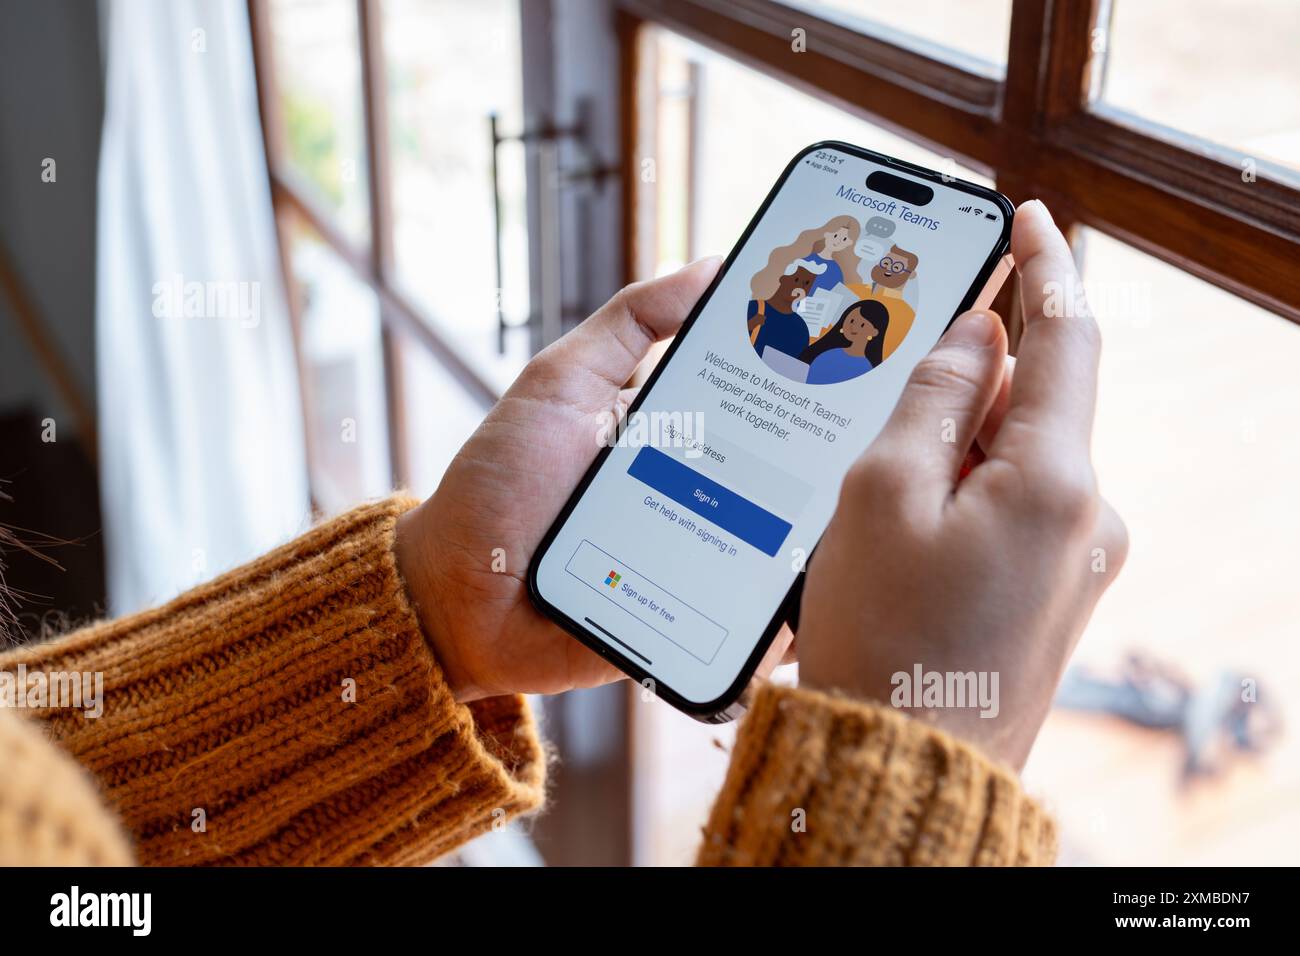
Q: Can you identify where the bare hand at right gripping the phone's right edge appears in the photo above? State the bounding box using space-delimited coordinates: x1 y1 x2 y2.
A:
798 202 1127 769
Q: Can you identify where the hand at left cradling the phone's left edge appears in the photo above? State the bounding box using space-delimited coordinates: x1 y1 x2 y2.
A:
397 259 719 701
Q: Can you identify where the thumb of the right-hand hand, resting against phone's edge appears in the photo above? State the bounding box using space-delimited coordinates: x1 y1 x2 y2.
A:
871 312 1006 494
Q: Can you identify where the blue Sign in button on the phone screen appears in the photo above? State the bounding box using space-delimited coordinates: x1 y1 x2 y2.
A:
628 445 790 557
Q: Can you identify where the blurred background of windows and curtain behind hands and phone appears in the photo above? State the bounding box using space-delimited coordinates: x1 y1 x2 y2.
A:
0 0 1300 865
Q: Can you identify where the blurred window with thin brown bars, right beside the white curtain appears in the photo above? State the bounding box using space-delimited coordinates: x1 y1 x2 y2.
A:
250 0 529 510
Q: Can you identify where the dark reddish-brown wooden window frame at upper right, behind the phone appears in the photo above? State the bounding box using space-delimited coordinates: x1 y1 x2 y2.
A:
616 0 1300 329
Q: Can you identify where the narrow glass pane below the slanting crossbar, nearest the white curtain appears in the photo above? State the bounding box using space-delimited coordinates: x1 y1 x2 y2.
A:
290 214 393 514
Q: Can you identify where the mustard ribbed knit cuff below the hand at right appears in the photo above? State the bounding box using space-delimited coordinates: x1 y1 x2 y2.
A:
699 685 1056 866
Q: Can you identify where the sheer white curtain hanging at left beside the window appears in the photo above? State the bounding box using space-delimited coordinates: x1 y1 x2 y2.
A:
96 0 309 614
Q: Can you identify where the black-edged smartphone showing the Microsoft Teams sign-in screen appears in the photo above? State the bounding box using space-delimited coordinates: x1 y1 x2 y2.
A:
528 142 1014 722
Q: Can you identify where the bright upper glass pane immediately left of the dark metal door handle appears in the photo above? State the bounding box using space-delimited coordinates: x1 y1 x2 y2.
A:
384 0 529 389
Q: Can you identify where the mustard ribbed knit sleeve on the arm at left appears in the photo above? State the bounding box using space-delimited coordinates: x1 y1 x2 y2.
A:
0 498 545 865
